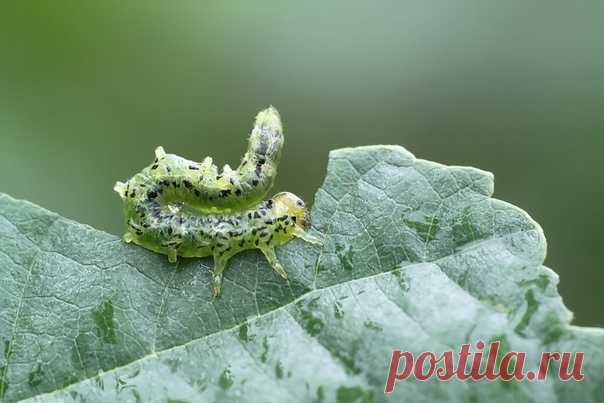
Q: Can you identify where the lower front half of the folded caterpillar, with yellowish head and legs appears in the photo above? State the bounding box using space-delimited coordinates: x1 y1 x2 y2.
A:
124 192 320 296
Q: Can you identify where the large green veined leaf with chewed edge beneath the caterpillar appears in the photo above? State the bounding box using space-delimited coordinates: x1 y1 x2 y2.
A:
0 146 604 402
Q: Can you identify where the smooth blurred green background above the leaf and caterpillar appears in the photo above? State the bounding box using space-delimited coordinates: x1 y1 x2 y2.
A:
0 0 604 326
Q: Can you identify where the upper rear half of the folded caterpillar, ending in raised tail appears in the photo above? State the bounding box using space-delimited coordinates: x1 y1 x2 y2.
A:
114 107 283 213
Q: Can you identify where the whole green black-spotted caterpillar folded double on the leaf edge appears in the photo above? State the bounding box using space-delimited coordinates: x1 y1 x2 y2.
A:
114 107 321 296
